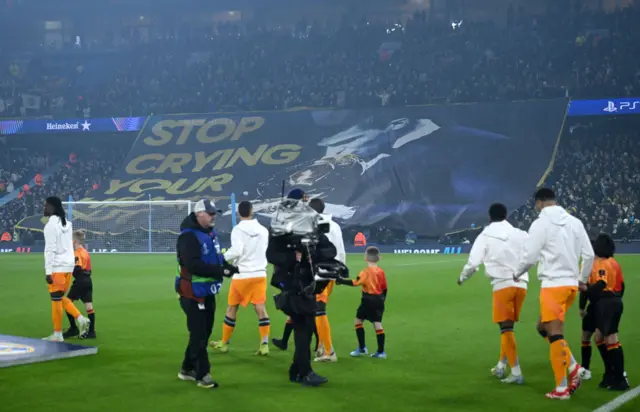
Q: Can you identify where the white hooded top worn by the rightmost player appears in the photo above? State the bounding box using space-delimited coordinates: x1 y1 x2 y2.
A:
515 205 594 288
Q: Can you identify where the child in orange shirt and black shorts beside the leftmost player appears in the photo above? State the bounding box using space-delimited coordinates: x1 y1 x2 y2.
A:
63 230 96 339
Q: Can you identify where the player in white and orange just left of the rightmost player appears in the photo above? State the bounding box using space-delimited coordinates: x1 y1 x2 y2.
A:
458 203 529 384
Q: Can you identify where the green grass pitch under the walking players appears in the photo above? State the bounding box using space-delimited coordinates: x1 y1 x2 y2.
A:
0 254 640 412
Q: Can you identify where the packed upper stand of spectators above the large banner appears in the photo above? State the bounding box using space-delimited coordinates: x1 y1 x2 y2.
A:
0 8 640 116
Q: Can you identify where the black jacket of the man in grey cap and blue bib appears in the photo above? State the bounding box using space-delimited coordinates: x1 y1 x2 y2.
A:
176 213 224 300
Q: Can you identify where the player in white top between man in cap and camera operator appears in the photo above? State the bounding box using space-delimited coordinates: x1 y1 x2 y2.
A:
211 201 271 356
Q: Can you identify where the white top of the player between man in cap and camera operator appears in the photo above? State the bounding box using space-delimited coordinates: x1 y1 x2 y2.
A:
224 219 269 279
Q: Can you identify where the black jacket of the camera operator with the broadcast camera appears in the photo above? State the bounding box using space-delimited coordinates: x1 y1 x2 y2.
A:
267 235 337 292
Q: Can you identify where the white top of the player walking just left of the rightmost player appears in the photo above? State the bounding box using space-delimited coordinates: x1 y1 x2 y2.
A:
460 220 529 292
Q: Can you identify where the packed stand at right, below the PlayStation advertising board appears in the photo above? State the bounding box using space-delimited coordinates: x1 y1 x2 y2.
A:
510 119 640 240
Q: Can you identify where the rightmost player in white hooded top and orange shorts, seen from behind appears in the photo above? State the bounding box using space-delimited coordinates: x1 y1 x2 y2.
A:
514 188 594 399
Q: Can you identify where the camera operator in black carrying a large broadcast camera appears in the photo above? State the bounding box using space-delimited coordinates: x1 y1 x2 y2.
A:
267 199 336 386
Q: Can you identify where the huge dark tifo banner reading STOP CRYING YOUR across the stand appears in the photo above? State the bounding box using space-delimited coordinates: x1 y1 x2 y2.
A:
63 100 567 235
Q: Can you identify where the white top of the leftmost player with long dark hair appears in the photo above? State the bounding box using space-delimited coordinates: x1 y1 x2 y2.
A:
44 216 76 275
